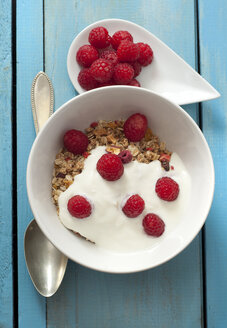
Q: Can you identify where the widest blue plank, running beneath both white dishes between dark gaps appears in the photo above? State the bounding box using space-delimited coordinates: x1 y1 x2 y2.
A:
45 0 202 328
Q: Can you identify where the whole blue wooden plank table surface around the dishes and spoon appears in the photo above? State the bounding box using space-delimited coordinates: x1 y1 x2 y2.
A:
0 0 227 328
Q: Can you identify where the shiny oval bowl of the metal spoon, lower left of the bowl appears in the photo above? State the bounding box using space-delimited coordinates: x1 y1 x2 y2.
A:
24 220 68 297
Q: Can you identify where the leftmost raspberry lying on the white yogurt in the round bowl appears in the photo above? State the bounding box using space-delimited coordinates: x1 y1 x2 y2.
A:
67 195 92 219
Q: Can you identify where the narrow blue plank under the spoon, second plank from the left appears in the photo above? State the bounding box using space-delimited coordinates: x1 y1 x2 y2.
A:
17 0 46 328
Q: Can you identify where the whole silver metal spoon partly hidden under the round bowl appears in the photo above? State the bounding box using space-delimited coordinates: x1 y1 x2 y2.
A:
24 72 68 297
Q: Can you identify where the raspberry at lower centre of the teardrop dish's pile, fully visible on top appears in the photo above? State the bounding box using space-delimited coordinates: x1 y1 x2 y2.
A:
90 58 113 83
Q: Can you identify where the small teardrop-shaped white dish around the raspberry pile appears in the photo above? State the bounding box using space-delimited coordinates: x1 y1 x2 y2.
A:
67 19 220 105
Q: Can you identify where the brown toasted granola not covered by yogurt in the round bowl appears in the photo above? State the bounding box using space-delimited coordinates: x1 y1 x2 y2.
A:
52 120 171 209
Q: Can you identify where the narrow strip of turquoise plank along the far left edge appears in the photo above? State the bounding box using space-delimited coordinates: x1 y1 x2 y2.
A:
0 0 13 328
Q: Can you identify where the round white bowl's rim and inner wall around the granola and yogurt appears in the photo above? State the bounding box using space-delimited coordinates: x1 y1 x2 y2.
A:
27 86 214 273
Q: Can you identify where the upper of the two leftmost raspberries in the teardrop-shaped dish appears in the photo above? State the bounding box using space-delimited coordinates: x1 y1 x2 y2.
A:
76 44 99 67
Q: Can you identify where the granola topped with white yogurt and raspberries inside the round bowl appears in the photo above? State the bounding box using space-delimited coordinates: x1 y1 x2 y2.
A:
52 113 190 252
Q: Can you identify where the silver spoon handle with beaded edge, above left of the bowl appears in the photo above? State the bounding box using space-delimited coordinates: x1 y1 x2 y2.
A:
31 72 54 134
